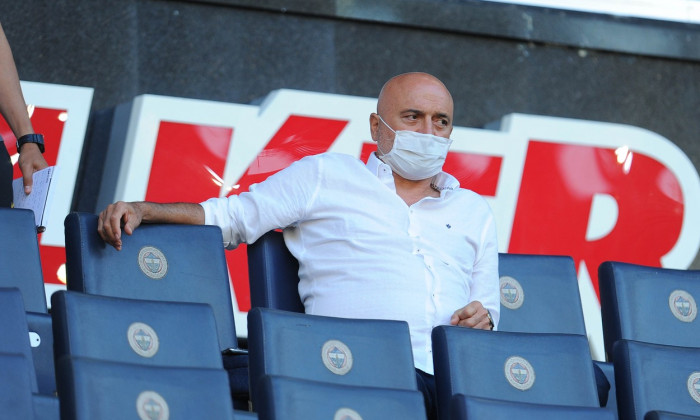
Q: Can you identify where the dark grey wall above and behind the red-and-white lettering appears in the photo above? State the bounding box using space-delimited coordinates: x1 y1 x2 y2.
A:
0 0 700 267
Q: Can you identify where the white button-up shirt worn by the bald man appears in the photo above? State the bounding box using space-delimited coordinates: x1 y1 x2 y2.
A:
202 153 500 374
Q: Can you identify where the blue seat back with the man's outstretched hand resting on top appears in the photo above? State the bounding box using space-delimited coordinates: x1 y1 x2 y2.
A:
65 213 238 349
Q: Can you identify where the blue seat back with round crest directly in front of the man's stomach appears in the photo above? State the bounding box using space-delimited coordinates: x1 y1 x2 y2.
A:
248 308 417 411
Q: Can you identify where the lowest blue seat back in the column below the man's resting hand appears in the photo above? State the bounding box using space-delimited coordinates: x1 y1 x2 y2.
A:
56 357 241 420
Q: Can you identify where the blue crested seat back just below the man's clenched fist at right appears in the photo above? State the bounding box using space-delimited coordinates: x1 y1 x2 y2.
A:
432 326 600 419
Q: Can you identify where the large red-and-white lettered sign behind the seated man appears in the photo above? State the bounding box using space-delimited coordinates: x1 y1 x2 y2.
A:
8 88 700 360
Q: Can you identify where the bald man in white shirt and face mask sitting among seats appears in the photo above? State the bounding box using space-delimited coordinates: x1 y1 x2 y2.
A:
98 73 500 418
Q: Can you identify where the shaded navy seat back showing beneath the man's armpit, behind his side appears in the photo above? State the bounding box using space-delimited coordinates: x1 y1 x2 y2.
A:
247 230 304 313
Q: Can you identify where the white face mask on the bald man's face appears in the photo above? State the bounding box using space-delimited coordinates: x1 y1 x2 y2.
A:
377 115 452 181
